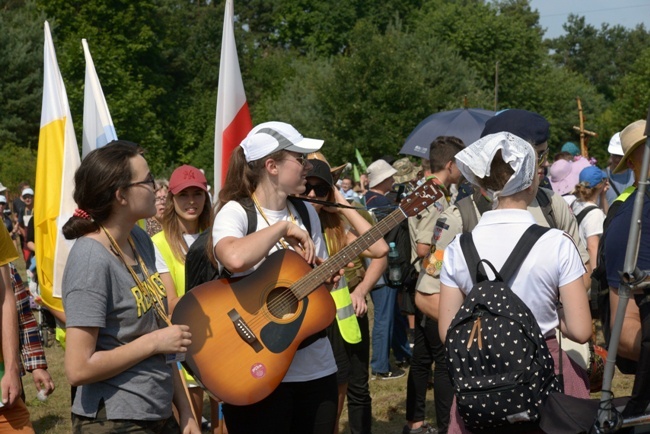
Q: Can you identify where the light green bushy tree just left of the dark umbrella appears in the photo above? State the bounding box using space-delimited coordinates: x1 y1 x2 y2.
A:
264 21 485 164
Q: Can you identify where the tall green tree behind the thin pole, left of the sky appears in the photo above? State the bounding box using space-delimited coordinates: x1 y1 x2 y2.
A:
415 0 546 108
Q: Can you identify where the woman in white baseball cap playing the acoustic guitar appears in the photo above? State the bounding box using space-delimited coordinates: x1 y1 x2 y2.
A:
213 122 338 434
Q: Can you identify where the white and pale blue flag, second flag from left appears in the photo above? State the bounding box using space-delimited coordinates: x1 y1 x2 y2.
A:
81 39 117 158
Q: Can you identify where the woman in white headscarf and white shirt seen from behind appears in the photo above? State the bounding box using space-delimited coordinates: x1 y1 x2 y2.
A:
438 133 592 433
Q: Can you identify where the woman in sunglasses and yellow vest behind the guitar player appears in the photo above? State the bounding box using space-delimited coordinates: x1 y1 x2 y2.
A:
303 159 388 433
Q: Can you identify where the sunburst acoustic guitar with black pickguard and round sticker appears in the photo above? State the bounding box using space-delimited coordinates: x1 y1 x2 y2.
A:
172 181 442 405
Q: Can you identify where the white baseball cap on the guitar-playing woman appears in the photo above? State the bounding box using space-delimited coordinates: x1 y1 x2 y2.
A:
239 122 324 163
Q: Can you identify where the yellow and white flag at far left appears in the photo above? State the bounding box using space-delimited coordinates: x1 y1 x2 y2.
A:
34 21 80 311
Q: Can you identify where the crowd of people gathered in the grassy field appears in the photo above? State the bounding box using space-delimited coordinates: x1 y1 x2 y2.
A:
0 109 650 434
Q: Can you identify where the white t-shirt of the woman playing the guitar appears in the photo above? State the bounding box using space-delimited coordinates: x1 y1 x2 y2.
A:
212 201 337 382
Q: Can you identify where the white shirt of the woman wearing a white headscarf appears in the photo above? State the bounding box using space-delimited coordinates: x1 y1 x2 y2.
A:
440 209 585 337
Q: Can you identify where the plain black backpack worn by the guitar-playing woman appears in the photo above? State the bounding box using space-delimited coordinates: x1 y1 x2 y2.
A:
185 196 311 292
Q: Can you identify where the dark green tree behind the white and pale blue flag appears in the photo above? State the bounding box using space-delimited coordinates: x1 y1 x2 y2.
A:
41 0 180 170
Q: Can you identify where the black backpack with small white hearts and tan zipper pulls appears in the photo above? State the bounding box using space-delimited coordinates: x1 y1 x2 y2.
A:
445 225 562 432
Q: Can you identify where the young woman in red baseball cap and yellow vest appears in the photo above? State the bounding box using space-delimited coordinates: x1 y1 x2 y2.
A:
151 165 218 427
